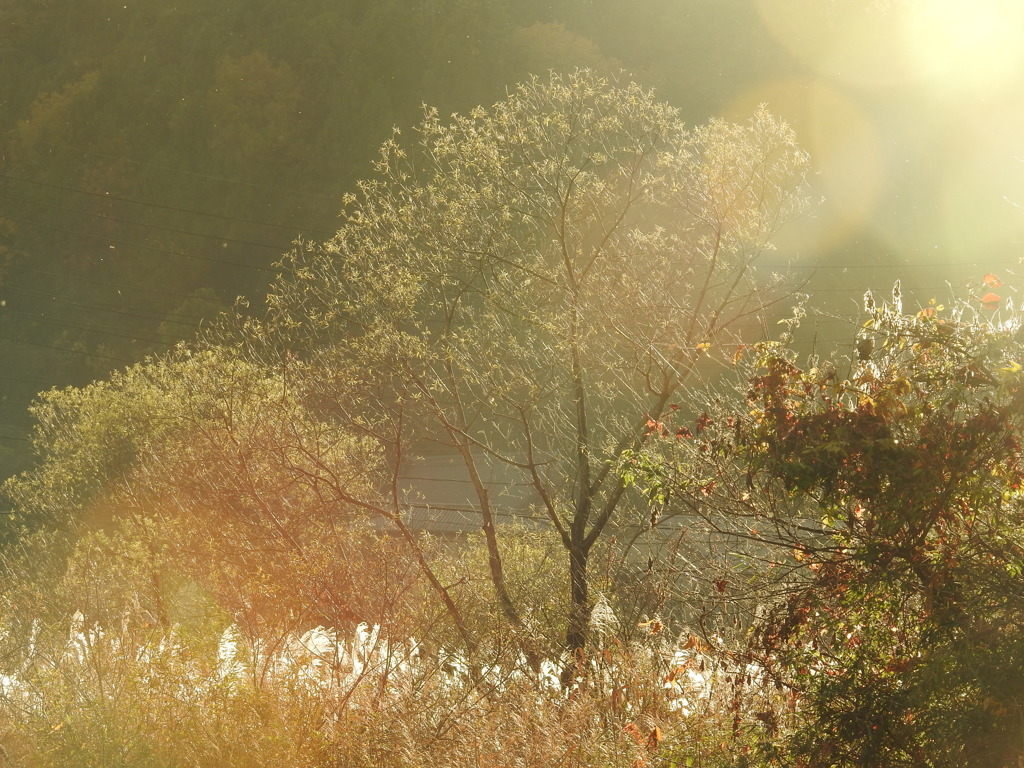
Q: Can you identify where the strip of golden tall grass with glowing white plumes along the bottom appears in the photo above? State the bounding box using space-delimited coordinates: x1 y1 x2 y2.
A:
0 613 780 768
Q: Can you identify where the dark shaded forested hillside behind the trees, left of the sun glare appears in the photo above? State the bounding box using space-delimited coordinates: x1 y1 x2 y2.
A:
0 0 790 475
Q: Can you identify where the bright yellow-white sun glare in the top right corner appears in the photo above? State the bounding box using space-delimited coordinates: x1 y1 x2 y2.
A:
742 0 1024 264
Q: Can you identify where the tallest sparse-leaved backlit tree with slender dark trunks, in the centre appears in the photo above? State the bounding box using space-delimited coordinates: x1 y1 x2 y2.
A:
260 72 807 663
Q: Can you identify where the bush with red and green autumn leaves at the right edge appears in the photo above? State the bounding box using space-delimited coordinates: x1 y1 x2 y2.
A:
631 284 1024 767
